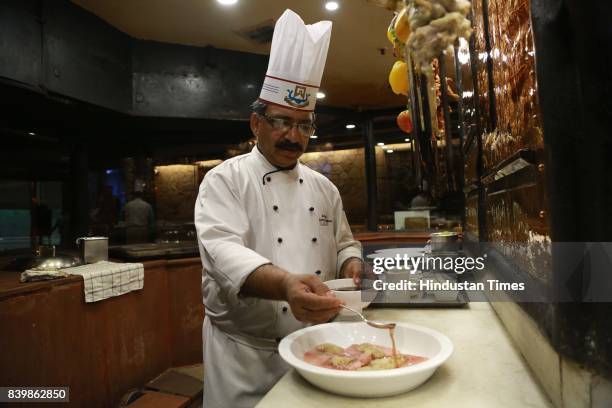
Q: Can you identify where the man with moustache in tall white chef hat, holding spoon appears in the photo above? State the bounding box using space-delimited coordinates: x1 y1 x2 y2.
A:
195 10 362 408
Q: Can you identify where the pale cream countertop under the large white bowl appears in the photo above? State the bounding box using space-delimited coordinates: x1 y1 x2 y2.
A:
257 303 552 408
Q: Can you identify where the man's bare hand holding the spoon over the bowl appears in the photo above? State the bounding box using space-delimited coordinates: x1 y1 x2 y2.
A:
285 275 343 323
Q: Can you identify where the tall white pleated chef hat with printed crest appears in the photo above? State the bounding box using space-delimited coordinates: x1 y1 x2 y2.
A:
259 9 332 111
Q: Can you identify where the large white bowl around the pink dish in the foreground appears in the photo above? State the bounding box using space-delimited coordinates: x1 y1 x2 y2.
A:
278 322 453 398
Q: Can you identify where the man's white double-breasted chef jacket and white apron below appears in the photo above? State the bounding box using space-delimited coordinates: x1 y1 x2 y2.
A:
195 147 361 408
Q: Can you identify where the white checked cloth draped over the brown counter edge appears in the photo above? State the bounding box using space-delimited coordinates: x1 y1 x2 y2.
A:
63 261 144 303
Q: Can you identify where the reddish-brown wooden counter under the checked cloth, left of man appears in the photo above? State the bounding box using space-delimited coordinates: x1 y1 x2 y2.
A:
0 258 204 408
